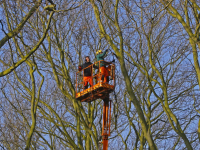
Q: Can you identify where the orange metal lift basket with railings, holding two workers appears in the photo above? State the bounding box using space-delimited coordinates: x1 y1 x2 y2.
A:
76 61 115 102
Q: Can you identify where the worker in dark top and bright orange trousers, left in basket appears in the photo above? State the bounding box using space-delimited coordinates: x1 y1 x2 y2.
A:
79 56 92 89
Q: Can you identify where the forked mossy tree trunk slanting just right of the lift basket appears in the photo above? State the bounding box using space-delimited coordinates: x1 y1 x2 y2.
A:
90 0 157 149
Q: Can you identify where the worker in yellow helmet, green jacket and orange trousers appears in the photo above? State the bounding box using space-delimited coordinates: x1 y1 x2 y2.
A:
96 50 111 83
